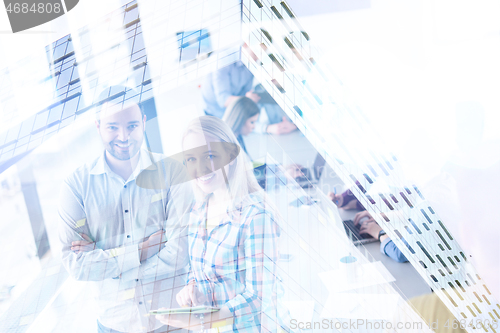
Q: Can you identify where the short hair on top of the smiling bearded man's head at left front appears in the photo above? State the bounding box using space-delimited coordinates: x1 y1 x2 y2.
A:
95 85 144 122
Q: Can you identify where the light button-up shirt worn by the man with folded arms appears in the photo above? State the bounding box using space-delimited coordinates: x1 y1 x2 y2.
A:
59 150 192 332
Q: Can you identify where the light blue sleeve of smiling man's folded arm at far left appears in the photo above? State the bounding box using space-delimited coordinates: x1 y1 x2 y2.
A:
58 181 140 281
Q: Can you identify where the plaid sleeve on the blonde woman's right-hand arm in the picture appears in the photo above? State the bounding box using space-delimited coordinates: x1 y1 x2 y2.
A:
225 213 279 321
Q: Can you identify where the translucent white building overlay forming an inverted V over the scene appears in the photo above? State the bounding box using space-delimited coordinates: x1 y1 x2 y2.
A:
0 0 494 332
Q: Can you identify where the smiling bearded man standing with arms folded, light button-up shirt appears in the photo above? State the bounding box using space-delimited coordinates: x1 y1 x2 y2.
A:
59 87 191 333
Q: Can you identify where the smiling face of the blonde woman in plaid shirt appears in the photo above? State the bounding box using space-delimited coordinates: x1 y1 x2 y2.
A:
183 133 231 194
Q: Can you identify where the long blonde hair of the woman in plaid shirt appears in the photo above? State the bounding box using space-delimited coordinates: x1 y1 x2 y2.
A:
182 116 264 209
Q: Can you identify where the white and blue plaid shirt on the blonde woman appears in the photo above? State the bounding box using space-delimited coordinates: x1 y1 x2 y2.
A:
187 195 280 332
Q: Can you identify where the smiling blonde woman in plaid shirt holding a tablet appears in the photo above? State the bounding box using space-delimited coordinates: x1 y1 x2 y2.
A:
157 116 286 332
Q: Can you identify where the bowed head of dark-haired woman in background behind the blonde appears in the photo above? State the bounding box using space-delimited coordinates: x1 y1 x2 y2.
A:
222 97 260 160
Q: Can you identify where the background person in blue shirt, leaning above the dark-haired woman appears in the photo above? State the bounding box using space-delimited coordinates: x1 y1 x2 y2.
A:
201 62 260 118
